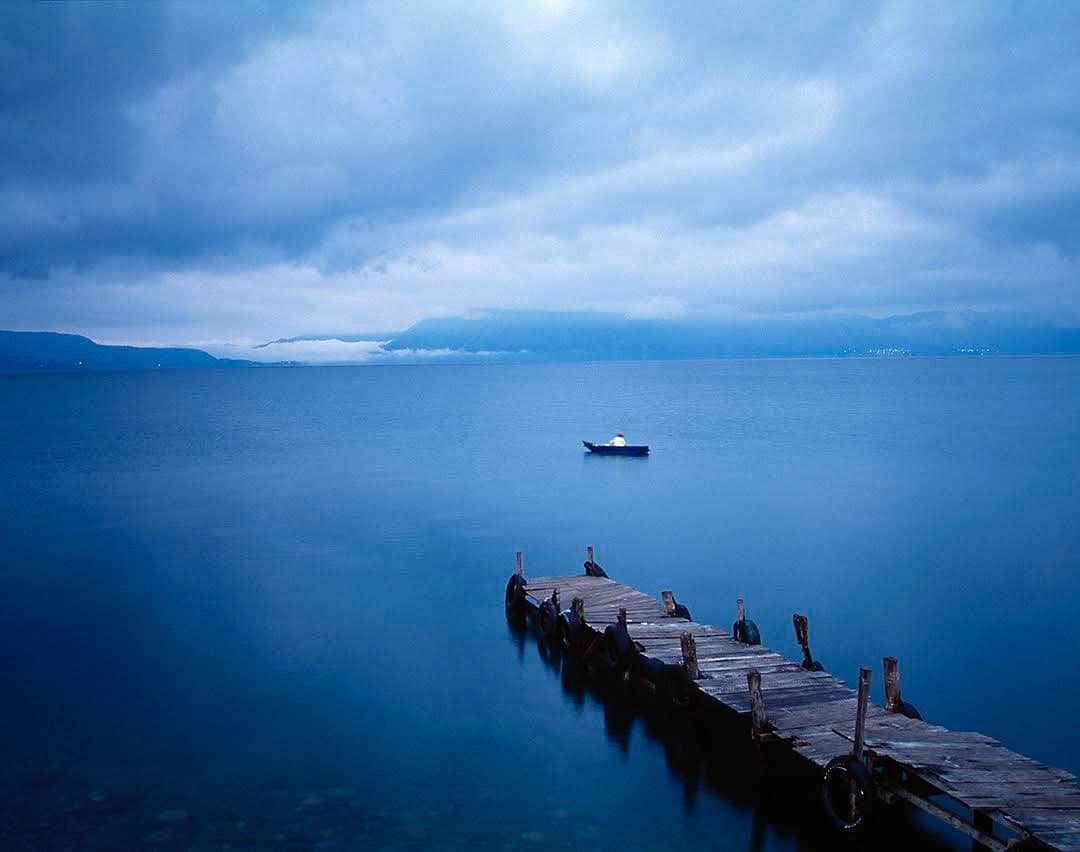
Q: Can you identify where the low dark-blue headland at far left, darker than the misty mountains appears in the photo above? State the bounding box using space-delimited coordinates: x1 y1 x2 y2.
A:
0 332 252 373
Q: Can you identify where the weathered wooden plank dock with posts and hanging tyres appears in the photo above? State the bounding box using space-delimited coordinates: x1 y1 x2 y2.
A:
507 549 1080 851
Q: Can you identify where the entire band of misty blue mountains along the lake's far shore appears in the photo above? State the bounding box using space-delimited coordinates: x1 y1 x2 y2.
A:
0 311 1080 373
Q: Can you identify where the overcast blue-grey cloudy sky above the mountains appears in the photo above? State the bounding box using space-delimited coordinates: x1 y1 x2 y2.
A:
0 0 1080 344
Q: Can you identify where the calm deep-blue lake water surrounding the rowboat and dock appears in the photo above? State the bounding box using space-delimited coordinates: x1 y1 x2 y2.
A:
0 359 1080 850
